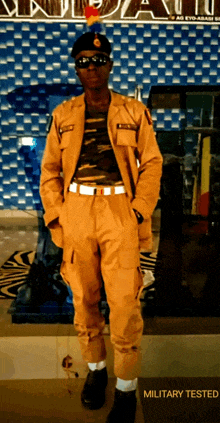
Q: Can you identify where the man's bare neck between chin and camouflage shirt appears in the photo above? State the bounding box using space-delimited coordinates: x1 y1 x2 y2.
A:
85 88 111 111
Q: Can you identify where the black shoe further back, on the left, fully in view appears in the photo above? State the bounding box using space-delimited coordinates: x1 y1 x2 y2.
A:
81 367 108 410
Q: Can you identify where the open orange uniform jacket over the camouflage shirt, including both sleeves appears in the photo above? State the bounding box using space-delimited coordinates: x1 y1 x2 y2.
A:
40 91 162 251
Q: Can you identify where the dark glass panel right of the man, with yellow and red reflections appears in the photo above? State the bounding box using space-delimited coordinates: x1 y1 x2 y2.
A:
149 87 220 316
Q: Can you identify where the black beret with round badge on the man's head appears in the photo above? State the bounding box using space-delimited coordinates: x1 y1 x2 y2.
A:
71 32 111 58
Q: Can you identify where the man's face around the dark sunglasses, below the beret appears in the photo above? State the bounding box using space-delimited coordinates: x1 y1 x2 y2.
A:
75 50 113 91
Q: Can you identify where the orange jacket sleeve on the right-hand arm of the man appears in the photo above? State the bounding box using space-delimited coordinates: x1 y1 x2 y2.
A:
131 107 163 219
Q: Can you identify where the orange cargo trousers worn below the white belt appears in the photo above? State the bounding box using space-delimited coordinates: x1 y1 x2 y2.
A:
59 192 143 380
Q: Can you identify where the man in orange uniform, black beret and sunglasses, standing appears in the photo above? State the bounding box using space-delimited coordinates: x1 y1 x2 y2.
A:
40 33 162 423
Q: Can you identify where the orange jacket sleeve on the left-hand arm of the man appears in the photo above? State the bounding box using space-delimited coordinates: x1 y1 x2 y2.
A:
40 113 64 227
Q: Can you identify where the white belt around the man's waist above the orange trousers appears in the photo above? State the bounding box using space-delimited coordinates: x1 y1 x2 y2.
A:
69 182 126 195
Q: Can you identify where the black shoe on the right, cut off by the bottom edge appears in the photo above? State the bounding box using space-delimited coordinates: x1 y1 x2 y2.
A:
106 388 137 423
